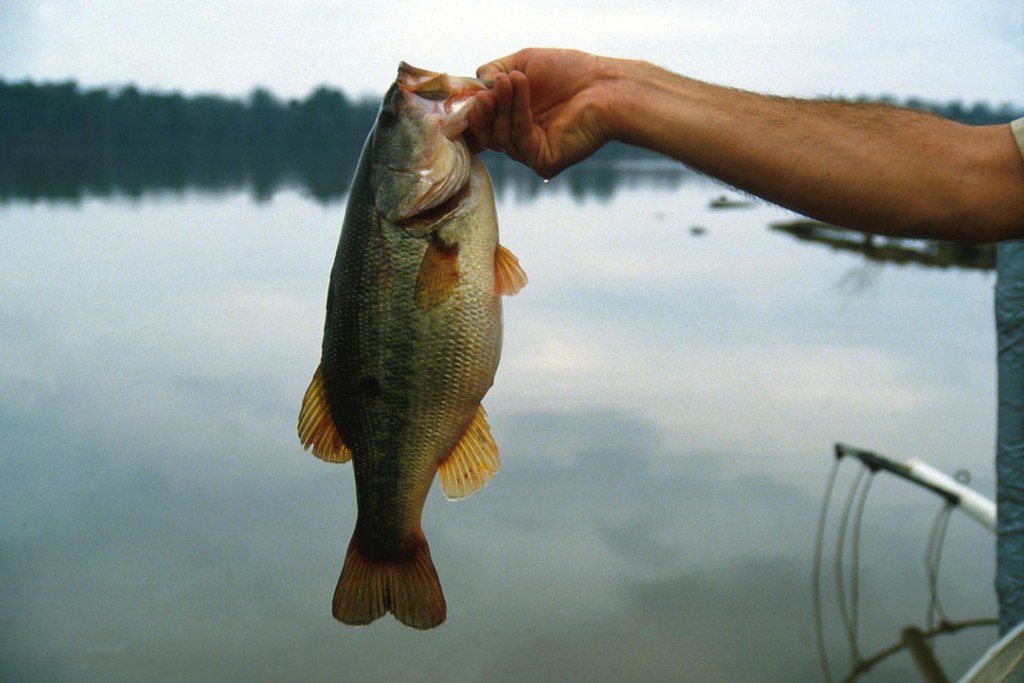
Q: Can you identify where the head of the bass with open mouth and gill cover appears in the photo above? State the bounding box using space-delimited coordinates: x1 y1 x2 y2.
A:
370 61 487 231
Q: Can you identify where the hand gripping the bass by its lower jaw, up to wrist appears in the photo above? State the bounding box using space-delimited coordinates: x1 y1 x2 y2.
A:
467 48 613 178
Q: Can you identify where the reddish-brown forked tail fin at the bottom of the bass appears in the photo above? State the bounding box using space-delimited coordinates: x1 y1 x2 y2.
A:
333 531 447 631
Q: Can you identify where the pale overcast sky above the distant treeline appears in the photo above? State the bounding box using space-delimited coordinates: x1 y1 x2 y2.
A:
0 0 1024 102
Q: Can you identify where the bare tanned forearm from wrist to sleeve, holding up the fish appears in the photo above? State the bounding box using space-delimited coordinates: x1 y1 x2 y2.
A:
602 59 1024 242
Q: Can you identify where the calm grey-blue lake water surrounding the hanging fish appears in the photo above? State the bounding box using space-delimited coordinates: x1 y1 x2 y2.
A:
0 162 995 681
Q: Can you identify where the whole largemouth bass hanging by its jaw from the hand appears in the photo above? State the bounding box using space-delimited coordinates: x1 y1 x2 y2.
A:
298 62 526 629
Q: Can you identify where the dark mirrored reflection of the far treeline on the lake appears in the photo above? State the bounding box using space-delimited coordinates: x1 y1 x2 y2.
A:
0 137 696 204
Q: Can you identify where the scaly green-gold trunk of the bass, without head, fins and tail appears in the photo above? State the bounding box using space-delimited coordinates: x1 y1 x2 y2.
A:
323 150 501 545
